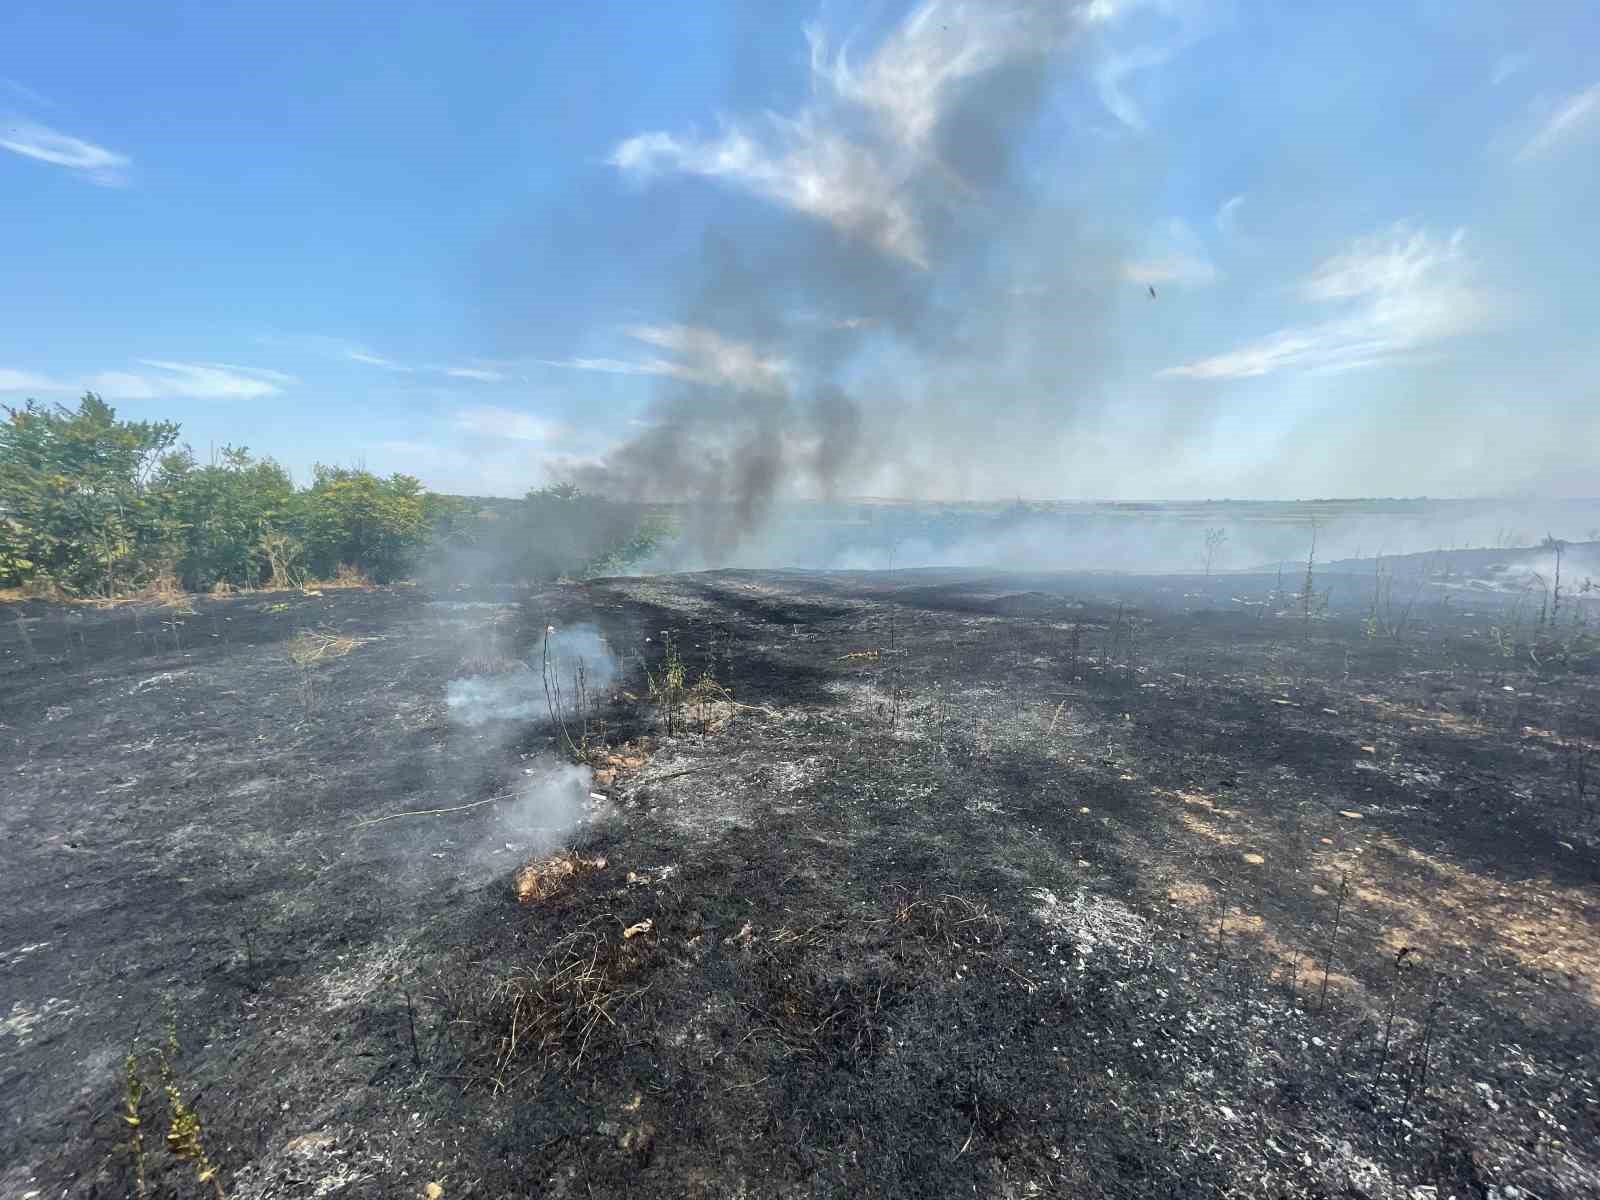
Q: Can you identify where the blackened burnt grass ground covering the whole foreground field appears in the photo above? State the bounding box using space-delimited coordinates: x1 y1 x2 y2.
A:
0 571 1600 1197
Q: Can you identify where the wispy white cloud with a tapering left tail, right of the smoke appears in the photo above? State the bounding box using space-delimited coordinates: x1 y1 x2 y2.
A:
1158 224 1498 379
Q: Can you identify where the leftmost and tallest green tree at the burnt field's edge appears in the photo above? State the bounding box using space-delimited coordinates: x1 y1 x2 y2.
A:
0 392 178 595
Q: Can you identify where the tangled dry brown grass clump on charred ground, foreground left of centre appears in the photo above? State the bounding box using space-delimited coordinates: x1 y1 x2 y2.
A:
474 928 653 1091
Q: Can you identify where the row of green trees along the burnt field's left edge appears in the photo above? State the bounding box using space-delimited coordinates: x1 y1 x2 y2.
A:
0 392 669 597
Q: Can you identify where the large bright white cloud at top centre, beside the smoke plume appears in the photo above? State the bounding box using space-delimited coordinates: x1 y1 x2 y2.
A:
610 0 1109 267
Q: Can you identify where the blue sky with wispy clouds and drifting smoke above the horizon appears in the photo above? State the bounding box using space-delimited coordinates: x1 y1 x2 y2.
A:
0 0 1600 498
